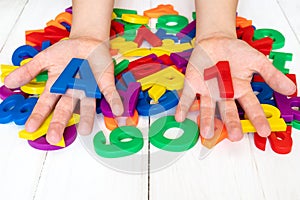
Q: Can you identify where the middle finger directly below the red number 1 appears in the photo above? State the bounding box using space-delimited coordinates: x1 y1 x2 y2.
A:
218 100 243 142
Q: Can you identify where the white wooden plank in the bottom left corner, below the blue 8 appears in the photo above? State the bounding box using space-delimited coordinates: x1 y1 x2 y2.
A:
0 123 46 200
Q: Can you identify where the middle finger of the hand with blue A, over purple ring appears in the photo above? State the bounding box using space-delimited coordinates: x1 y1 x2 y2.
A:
46 96 78 145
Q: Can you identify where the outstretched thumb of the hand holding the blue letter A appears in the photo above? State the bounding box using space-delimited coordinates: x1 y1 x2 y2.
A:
4 53 43 88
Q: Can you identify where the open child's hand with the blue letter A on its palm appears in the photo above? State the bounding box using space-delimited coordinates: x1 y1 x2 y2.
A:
5 38 123 144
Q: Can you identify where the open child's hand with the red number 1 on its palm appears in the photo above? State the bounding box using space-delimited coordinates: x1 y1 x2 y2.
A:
176 36 296 141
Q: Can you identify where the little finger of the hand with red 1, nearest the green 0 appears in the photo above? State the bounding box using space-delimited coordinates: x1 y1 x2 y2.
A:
175 79 196 122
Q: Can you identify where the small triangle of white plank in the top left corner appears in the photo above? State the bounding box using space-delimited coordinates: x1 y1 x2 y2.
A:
0 0 28 49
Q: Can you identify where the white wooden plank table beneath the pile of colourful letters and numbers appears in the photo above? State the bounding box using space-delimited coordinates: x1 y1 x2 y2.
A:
0 0 300 200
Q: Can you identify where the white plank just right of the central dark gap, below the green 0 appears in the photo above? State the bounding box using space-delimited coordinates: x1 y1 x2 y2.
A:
150 108 263 199
